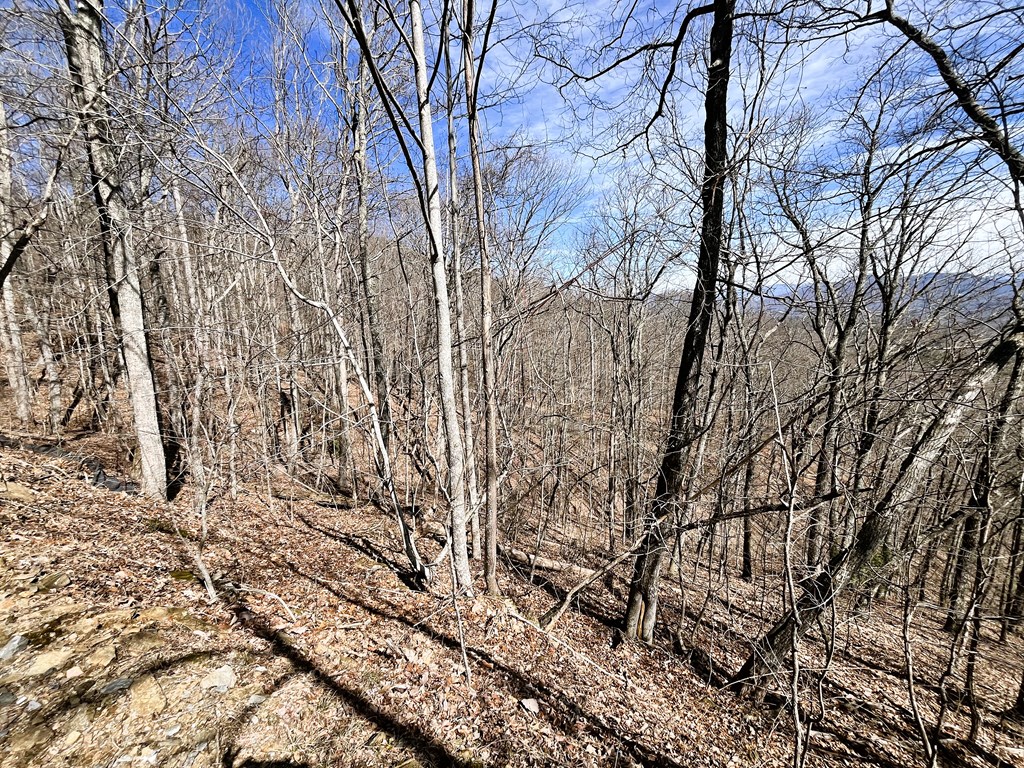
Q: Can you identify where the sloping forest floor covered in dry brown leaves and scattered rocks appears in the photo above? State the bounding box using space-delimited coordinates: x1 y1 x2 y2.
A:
0 434 1024 768
